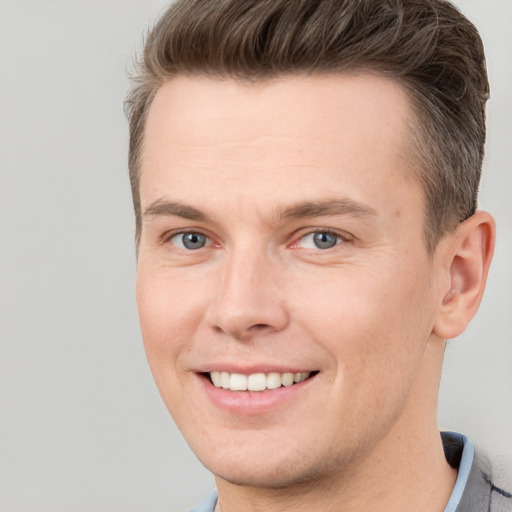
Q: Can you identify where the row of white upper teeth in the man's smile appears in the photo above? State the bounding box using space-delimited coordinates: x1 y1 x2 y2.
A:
210 372 311 391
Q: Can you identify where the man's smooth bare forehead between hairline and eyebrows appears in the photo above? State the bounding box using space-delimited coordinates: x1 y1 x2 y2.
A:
141 74 420 220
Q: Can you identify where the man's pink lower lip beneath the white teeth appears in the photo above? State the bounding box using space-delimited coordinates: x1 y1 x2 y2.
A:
198 375 317 416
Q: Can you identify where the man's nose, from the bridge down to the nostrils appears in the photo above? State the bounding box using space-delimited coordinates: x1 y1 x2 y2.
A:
206 248 289 341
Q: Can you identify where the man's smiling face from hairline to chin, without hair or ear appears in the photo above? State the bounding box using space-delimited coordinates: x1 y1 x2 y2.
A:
137 75 441 487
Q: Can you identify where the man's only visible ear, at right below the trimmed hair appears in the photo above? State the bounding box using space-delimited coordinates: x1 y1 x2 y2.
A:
434 211 496 339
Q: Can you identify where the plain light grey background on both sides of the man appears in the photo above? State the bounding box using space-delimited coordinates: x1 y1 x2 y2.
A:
0 0 512 512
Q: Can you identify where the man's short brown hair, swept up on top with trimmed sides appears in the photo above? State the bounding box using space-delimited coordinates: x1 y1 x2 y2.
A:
125 0 489 253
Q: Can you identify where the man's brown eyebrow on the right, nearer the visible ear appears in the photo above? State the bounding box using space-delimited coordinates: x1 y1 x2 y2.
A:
278 198 377 220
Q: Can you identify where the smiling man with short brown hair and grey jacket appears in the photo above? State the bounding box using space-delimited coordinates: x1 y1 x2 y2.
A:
127 0 512 512
